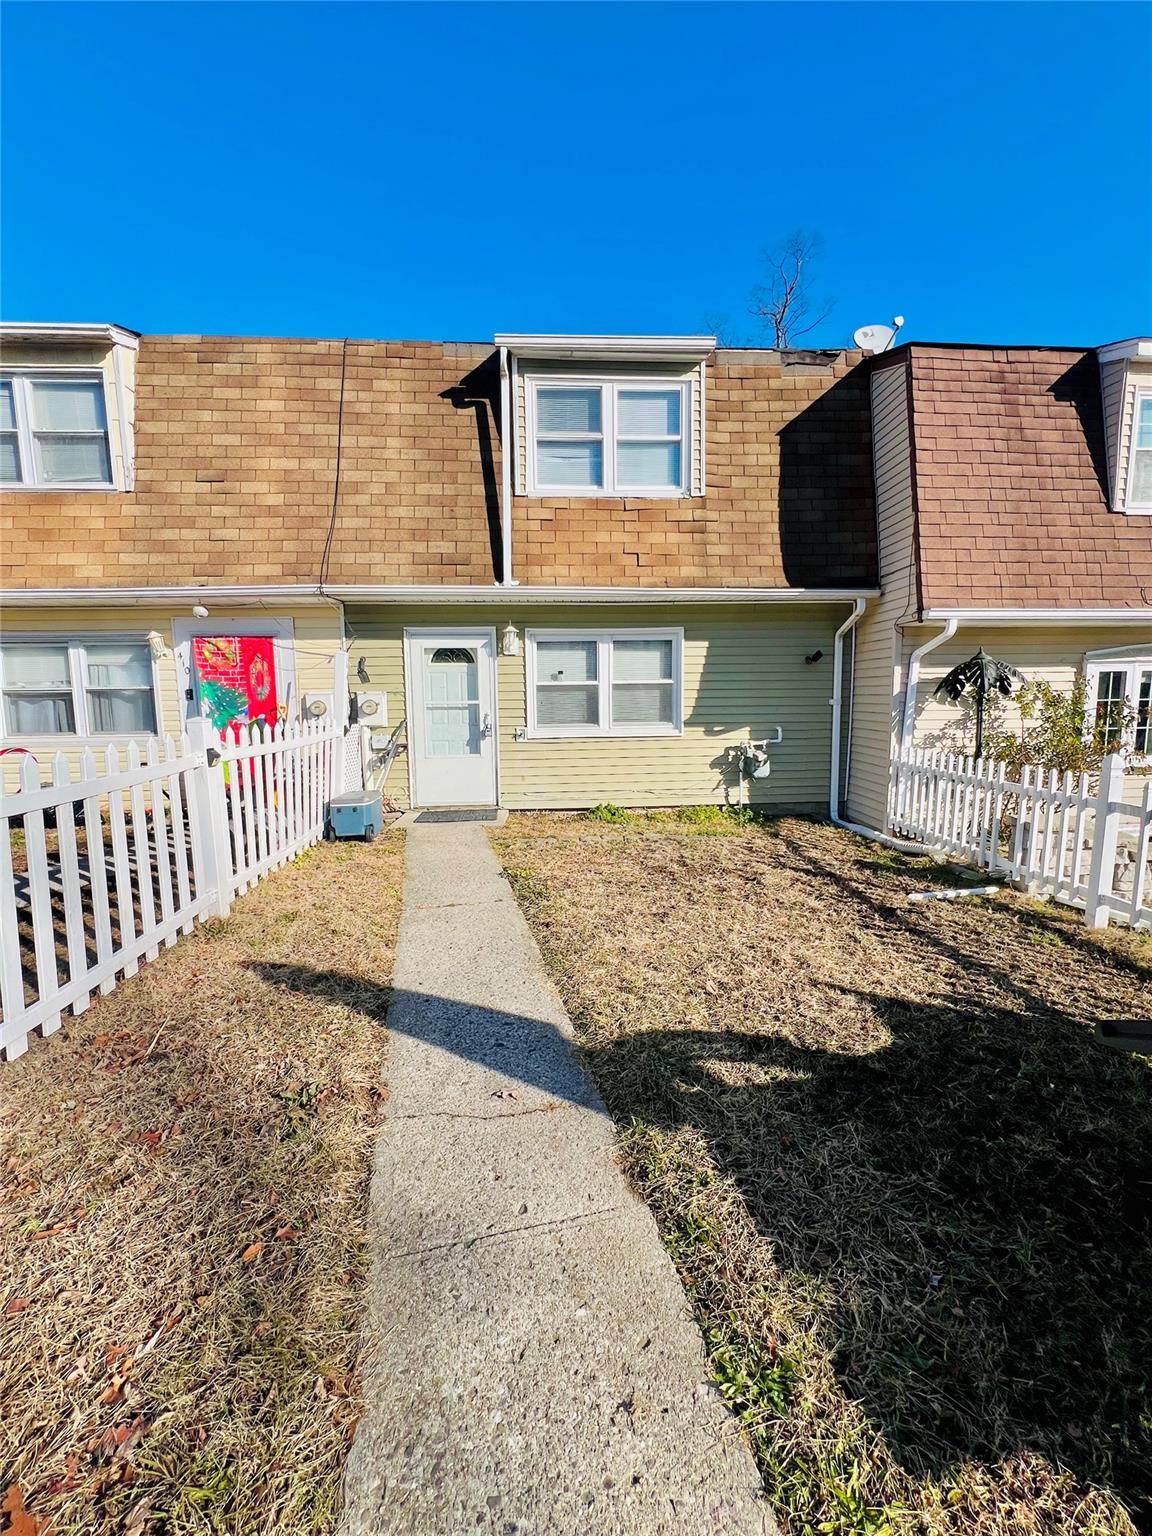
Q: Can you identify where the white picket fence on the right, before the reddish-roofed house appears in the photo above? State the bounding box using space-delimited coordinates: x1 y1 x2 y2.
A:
889 748 1152 928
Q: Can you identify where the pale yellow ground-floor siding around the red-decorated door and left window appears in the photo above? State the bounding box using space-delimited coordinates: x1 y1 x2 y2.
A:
0 604 341 790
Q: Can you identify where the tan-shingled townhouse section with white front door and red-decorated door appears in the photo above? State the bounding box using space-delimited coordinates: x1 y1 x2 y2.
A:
0 324 877 811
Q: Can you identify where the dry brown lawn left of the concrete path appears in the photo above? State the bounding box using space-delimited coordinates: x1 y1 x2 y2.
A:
0 833 402 1536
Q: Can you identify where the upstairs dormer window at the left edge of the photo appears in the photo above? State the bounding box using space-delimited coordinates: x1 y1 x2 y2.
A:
0 370 114 490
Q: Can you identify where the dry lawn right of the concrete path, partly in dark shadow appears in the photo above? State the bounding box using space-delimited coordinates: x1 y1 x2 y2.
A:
496 813 1152 1536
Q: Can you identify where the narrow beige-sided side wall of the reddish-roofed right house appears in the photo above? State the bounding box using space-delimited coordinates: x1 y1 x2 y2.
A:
846 362 915 828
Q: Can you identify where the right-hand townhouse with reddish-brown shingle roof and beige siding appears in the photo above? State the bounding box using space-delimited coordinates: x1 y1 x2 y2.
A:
848 338 1152 826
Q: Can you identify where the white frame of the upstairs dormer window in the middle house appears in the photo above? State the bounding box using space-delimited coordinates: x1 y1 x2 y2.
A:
524 373 696 501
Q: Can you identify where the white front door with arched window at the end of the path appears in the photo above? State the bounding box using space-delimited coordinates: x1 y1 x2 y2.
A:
404 628 496 805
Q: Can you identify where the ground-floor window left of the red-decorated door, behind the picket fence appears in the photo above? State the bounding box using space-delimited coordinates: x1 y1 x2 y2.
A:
0 639 157 736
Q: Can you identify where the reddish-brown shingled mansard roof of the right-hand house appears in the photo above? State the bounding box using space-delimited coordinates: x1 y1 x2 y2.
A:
906 343 1152 608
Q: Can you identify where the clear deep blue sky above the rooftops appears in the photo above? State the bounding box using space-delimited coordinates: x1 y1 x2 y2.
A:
2 0 1152 346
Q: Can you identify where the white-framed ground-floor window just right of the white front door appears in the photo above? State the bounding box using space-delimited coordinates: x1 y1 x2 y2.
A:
527 630 684 736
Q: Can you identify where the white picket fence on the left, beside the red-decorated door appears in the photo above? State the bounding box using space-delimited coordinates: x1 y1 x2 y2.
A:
0 720 344 1060
